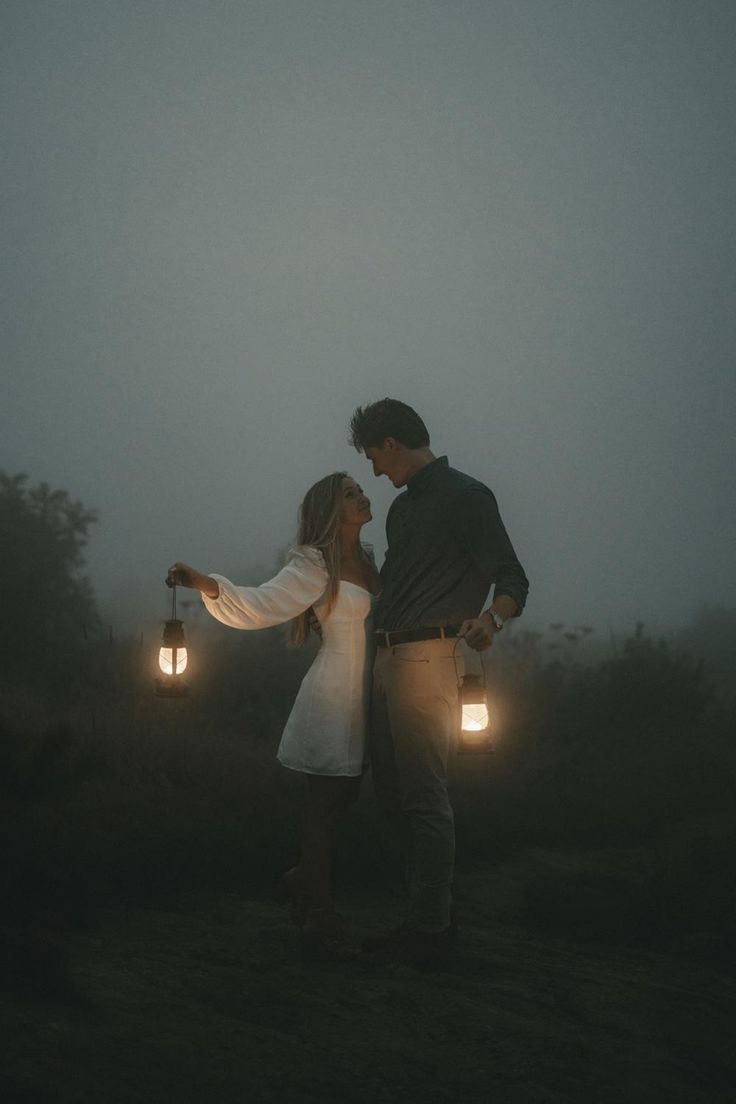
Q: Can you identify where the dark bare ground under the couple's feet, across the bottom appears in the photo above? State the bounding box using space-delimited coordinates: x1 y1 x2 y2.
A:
0 870 736 1104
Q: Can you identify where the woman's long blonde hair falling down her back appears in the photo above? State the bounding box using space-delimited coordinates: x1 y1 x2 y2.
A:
289 471 348 647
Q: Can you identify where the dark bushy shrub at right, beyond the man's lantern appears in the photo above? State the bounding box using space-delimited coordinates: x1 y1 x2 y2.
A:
474 628 736 846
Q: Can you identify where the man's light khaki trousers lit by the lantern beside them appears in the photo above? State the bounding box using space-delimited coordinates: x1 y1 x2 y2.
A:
371 639 463 931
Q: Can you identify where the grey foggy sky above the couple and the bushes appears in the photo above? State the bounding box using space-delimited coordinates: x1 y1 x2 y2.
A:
0 0 736 631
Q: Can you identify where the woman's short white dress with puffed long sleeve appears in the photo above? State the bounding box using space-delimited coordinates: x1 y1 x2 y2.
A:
202 545 374 776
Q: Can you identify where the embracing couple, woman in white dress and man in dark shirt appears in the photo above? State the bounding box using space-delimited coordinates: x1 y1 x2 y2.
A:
168 399 529 966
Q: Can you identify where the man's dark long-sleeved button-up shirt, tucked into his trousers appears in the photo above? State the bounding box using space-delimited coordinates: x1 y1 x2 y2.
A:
375 456 529 631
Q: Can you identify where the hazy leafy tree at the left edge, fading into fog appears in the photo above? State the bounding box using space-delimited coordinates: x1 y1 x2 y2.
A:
0 470 99 686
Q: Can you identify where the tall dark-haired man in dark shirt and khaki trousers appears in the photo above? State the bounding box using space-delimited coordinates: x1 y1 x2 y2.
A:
350 399 529 965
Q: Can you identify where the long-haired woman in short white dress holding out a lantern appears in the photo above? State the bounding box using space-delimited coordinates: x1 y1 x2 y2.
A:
167 471 380 952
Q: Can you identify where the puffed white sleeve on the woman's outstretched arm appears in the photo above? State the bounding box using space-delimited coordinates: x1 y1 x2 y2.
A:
202 545 329 628
